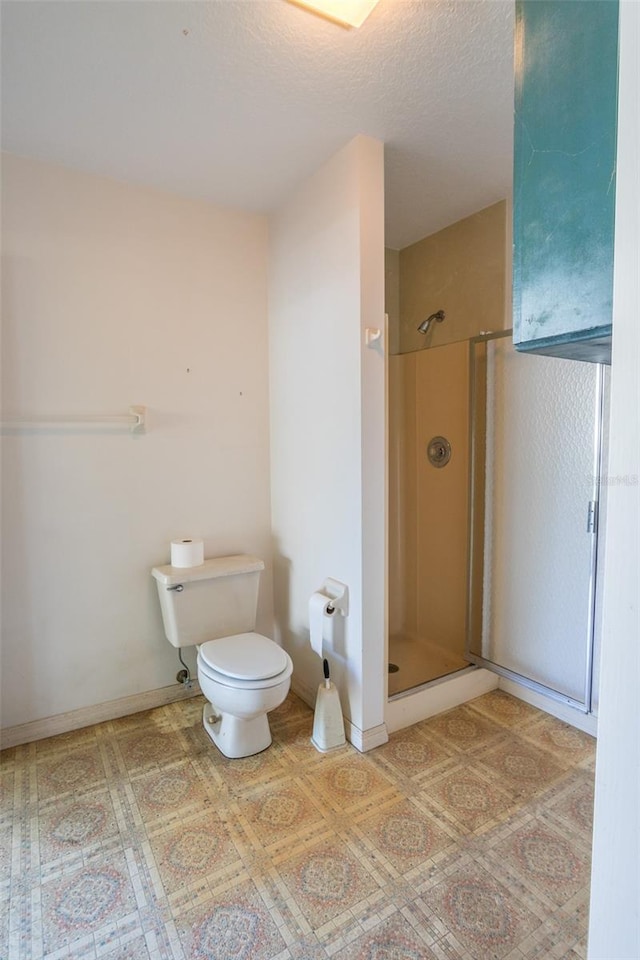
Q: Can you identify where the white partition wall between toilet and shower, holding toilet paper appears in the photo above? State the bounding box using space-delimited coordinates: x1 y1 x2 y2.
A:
269 137 386 748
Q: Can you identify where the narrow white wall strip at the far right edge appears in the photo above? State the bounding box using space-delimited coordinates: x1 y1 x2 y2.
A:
588 0 640 960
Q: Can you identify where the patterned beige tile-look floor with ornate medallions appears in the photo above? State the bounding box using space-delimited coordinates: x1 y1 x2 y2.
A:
0 692 594 960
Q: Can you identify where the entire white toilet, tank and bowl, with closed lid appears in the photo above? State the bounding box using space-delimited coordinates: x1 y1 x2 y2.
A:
151 555 293 759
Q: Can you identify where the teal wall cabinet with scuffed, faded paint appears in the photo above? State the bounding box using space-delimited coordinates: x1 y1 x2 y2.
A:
513 0 618 362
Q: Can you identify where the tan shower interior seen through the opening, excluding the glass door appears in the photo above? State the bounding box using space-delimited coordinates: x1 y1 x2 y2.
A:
386 202 507 697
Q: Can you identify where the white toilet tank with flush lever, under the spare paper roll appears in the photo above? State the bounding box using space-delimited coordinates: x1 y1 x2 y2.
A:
151 554 264 647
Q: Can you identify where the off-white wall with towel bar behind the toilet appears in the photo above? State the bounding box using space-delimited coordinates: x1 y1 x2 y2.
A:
2 156 273 726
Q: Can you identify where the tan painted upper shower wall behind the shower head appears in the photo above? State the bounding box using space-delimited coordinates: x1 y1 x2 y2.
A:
398 200 511 353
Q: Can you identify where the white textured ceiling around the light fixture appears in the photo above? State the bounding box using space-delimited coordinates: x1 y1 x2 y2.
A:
2 0 514 248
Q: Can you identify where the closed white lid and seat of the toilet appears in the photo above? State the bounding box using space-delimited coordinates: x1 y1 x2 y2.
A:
198 633 293 690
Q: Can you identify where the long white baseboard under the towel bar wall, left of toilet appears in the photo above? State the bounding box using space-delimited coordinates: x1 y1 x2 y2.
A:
0 680 200 750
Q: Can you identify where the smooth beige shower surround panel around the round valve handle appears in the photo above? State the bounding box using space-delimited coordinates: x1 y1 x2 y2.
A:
389 342 469 656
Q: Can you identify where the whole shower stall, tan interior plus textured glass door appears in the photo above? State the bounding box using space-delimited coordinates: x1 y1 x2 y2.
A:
387 205 608 713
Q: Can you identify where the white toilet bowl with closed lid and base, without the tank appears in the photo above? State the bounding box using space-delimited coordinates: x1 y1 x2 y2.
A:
197 633 293 760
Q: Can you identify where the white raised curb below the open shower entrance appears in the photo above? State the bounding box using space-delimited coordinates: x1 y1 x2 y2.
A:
385 667 498 733
